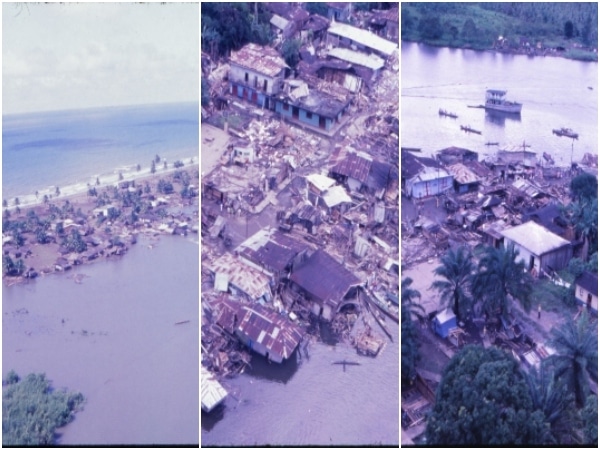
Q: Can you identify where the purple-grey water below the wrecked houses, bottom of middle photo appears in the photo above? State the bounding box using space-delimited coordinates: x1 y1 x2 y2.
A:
201 320 400 446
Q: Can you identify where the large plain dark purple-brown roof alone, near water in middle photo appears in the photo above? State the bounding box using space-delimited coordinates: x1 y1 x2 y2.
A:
290 250 361 307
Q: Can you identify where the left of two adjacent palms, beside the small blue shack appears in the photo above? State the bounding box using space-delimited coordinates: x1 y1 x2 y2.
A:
430 247 475 322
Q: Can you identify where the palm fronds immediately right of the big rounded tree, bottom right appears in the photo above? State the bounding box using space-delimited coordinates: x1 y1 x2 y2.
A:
525 362 580 444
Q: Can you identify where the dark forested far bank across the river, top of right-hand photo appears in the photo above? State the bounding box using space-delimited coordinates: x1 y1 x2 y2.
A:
401 2 598 61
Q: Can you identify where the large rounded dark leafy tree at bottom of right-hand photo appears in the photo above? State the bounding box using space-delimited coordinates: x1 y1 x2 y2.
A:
426 345 549 446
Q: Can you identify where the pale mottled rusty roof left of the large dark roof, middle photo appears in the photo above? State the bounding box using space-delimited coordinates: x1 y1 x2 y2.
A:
210 253 271 299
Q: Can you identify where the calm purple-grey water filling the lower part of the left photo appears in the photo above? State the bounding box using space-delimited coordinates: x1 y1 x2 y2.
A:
2 236 200 445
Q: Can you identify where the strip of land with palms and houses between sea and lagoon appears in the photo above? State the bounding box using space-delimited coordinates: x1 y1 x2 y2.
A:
2 162 199 284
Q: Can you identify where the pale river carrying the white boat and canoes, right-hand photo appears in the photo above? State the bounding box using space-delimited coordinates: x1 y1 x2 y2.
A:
400 42 598 166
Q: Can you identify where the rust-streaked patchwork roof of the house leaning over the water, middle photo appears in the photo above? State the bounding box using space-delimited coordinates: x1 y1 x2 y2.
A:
237 304 306 359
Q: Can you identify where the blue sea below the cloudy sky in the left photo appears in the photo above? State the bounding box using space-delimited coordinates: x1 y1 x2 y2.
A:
2 102 199 204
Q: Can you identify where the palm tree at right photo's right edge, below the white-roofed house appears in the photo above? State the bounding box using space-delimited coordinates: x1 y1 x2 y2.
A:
551 310 598 407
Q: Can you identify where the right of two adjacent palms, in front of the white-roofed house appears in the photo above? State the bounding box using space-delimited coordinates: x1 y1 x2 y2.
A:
472 244 533 318
